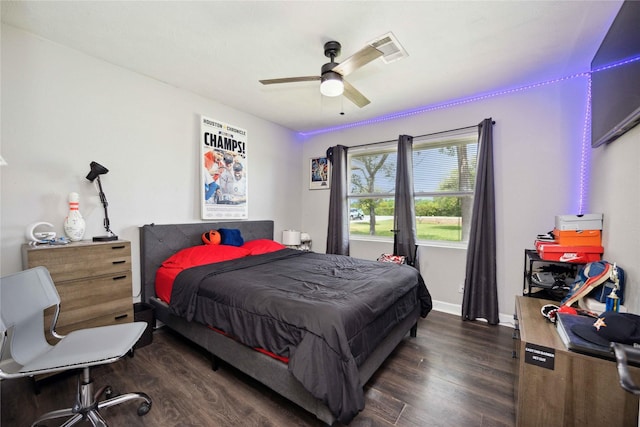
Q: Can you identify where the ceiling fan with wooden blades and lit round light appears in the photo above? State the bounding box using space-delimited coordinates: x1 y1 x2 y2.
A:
260 33 406 108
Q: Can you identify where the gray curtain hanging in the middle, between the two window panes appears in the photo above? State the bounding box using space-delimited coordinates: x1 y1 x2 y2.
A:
393 135 416 265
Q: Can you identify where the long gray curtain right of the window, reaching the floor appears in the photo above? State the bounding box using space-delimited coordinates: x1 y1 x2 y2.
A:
462 119 500 325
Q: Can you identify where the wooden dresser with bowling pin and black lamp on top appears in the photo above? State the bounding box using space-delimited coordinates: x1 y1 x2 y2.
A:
22 240 133 343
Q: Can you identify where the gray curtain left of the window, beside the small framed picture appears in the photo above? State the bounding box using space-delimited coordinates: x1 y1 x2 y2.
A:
327 145 349 255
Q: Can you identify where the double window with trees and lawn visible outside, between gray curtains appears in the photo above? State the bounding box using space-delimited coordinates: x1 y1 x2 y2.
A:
347 129 478 242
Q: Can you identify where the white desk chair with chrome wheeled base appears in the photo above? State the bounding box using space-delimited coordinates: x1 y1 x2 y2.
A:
0 267 151 427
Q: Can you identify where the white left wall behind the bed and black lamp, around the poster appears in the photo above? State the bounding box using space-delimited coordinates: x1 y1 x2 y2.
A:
0 24 302 295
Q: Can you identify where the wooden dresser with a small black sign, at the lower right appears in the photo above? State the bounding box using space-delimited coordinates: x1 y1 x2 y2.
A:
514 296 640 427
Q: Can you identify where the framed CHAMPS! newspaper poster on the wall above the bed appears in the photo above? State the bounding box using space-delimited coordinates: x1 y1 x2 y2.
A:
198 117 249 219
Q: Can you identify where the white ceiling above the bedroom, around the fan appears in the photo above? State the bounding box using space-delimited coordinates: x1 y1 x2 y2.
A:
1 0 622 131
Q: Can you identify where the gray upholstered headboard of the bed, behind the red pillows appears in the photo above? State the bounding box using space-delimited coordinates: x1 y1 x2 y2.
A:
140 220 273 302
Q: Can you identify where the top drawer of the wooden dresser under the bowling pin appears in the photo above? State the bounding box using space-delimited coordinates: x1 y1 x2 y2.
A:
25 241 131 285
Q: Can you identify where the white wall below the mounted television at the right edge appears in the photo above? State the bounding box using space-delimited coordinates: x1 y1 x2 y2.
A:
591 126 640 313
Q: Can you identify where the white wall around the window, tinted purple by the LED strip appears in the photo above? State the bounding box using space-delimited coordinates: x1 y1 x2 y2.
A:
302 78 586 321
